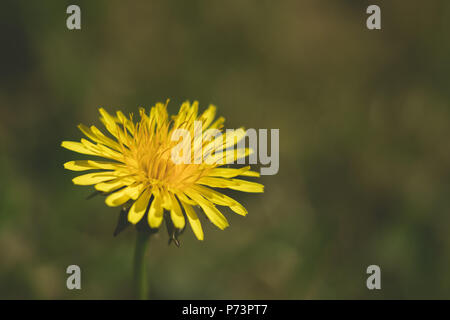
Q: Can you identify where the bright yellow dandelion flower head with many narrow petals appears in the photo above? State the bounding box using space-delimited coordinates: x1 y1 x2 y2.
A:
62 102 264 240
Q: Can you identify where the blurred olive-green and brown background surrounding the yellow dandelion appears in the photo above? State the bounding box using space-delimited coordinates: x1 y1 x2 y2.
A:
0 0 450 299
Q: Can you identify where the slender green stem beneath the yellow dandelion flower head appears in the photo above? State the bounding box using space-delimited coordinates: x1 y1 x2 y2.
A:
133 231 150 300
